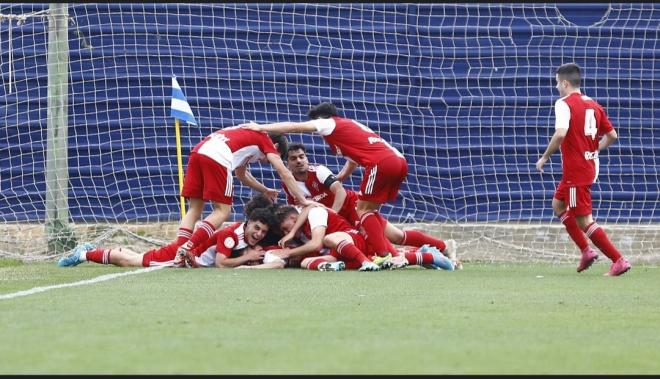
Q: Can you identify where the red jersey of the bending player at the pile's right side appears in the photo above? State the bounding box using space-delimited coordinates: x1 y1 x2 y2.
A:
313 116 403 167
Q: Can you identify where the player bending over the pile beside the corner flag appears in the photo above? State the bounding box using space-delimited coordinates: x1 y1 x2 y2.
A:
176 127 309 257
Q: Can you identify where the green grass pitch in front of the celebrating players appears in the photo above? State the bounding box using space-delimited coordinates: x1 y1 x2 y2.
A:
0 260 660 374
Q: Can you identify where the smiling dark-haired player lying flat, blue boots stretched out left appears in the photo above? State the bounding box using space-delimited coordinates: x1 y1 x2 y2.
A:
58 202 275 267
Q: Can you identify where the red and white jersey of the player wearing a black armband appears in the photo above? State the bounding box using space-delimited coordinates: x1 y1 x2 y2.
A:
282 164 357 222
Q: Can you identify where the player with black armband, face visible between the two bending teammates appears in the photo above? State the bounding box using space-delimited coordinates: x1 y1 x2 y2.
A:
281 144 462 269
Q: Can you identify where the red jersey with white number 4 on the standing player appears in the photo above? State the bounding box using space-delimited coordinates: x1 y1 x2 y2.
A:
555 92 614 186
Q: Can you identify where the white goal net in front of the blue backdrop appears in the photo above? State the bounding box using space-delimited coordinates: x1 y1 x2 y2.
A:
0 3 660 262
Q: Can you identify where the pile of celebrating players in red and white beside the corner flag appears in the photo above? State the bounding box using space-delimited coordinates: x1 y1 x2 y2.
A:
58 103 462 271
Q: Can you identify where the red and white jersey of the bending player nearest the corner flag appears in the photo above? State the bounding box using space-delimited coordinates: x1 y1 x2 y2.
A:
192 126 279 170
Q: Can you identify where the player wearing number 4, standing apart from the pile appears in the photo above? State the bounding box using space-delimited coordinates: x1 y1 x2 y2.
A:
536 63 631 276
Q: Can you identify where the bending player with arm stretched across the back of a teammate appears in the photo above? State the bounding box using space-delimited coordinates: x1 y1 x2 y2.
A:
241 103 408 257
